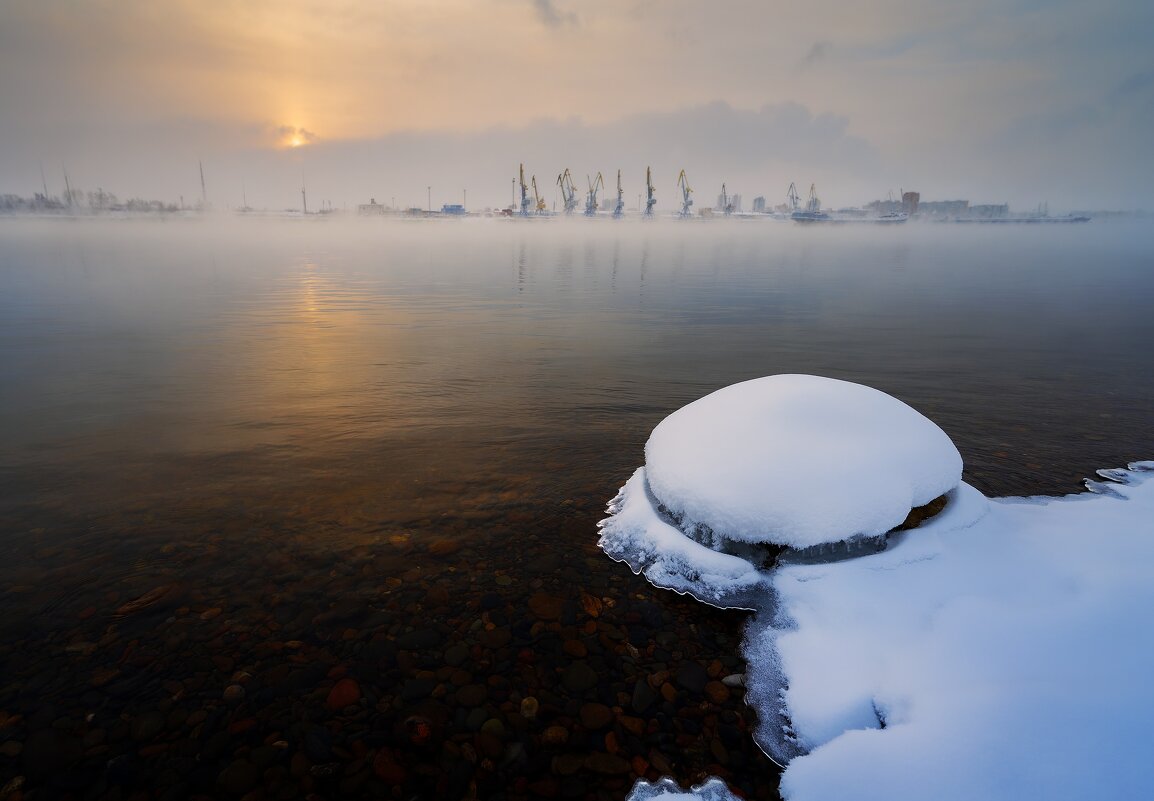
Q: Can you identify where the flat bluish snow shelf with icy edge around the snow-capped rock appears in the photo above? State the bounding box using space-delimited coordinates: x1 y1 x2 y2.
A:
601 373 1154 801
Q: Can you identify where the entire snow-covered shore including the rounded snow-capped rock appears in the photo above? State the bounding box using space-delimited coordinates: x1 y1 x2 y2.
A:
601 376 1154 801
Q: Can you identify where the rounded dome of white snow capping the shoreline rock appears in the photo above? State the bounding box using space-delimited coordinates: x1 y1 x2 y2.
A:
645 375 961 548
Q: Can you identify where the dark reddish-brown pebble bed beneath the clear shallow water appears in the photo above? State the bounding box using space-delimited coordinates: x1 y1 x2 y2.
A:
0 457 778 801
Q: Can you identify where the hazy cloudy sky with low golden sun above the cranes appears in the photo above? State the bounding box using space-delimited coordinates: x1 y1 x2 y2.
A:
0 0 1154 211
